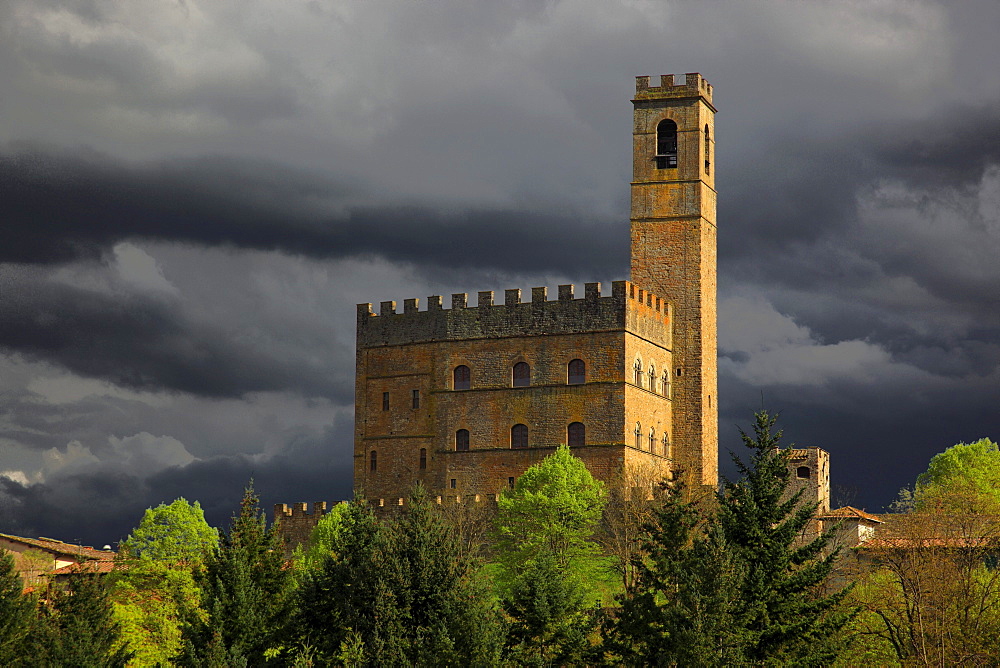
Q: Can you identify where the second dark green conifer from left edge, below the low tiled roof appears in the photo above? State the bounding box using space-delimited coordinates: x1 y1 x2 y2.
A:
29 572 132 668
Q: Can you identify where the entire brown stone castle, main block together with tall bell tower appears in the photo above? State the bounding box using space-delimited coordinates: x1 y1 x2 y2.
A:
354 73 718 506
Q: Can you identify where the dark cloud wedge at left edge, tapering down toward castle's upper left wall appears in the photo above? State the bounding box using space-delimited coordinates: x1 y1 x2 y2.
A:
0 267 352 402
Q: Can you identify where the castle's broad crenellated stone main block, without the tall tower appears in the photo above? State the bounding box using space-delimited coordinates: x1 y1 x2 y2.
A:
354 281 673 507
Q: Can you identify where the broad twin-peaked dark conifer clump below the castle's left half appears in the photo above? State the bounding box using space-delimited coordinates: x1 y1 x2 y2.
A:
299 486 501 666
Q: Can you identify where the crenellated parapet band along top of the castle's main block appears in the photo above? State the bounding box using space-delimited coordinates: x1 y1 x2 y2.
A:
357 281 671 348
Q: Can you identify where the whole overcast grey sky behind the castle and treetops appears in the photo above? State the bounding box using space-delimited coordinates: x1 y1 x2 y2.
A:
0 0 1000 544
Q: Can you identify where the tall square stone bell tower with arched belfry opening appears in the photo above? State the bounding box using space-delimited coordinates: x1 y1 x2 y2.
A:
631 73 719 487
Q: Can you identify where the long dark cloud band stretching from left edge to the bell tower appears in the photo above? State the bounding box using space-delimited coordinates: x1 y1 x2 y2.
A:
0 149 628 276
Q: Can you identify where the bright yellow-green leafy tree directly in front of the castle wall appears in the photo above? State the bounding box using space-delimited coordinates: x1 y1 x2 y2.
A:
495 445 607 582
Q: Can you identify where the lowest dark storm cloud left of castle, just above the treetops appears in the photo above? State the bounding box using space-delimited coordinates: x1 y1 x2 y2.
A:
0 419 352 547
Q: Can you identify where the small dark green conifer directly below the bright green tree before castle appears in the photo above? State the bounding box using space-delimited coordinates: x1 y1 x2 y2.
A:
503 554 597 666
